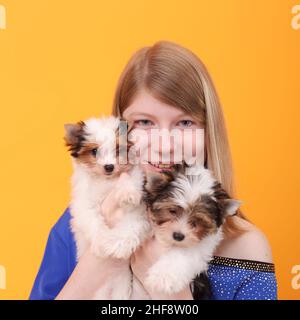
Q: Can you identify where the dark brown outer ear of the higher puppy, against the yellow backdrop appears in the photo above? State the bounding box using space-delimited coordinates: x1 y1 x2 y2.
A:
64 121 85 157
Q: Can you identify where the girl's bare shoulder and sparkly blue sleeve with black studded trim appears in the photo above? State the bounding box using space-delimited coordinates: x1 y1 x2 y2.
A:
208 217 277 300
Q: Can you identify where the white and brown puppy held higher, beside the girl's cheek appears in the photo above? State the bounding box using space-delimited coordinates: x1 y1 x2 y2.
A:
64 116 150 299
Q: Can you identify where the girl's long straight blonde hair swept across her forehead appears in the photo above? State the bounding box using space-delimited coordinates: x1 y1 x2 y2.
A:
112 41 247 234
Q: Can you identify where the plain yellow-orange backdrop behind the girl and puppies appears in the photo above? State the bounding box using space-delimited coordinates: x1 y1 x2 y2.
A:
0 0 300 299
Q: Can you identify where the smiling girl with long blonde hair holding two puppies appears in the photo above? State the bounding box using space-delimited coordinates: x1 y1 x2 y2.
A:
30 41 277 299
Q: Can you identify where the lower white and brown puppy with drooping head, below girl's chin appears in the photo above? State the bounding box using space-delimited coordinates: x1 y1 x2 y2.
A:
144 166 241 294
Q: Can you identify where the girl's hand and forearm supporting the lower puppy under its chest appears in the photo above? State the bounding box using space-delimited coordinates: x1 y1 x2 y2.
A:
130 236 193 300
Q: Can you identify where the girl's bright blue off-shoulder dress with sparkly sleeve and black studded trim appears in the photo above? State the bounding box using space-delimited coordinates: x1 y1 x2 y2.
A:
30 208 277 300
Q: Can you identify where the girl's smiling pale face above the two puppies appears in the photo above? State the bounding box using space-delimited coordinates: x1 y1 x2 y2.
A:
123 90 204 172
